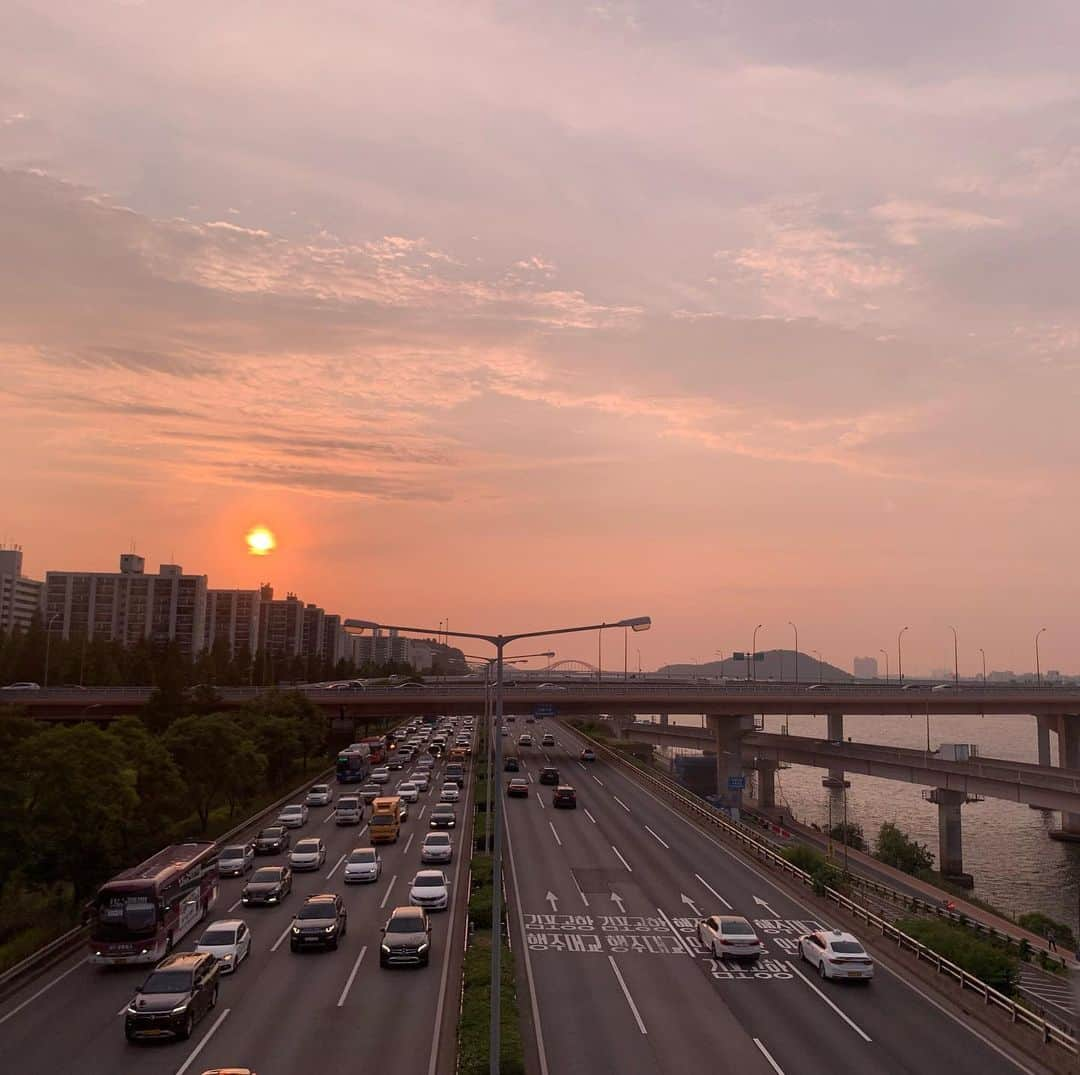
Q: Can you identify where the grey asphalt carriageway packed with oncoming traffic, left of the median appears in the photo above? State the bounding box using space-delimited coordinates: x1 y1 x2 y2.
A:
0 743 472 1075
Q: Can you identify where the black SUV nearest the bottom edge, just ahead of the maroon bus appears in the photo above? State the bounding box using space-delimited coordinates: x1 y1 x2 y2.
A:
124 952 218 1042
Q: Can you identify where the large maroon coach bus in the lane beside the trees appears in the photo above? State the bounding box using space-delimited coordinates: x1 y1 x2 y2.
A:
90 843 219 965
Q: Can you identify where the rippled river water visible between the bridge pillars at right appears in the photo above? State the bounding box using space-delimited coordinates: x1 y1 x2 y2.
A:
652 715 1080 926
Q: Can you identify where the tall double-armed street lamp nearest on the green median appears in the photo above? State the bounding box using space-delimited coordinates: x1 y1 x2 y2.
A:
342 616 652 1075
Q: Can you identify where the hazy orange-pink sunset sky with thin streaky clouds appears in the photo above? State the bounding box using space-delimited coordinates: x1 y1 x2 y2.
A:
0 0 1080 674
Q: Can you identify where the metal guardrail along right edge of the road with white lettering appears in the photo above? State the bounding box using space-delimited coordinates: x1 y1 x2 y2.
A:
573 728 1080 1053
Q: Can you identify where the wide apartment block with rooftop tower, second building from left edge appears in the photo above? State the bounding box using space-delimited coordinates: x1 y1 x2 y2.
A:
43 553 206 657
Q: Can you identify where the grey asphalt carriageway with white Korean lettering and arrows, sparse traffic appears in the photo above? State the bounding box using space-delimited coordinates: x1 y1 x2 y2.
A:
502 721 1036 1075
